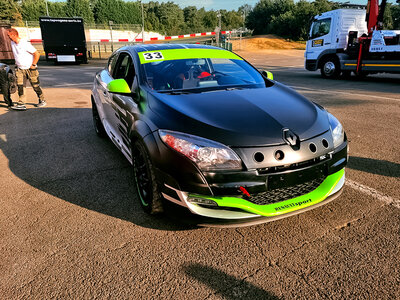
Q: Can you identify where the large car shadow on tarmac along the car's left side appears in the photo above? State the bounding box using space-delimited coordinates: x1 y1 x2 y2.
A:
0 107 197 231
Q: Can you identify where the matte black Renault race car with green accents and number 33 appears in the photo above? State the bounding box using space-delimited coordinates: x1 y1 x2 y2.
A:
91 44 347 224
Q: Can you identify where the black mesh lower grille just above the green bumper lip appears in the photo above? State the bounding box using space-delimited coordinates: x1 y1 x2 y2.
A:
247 176 326 205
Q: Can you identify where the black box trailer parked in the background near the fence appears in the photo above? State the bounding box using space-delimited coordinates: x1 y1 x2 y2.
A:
39 17 87 64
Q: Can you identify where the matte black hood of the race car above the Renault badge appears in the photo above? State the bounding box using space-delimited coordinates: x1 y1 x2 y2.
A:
149 83 329 147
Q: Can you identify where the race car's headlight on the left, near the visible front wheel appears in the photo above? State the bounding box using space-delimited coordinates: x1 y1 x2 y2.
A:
158 130 242 171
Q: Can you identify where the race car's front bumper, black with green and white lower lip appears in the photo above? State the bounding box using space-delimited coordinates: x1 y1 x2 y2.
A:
155 140 347 226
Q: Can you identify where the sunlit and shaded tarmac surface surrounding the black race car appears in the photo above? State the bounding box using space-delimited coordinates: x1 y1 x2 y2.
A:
0 50 400 299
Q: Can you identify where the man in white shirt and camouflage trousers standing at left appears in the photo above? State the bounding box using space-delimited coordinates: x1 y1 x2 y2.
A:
7 28 46 110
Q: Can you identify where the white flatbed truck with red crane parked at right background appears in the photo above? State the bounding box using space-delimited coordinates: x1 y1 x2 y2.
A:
304 9 400 78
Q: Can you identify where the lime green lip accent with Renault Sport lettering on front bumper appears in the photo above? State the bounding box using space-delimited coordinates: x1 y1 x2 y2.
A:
189 169 344 217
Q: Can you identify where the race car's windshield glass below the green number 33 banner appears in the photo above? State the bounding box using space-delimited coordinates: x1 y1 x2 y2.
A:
143 58 265 92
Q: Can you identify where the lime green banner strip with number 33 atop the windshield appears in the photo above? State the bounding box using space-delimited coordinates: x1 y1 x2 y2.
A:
138 48 243 64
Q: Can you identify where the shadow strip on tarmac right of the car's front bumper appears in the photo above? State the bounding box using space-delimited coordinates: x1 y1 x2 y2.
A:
347 156 400 178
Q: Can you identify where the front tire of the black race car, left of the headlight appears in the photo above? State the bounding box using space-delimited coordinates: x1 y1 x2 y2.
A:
132 140 163 215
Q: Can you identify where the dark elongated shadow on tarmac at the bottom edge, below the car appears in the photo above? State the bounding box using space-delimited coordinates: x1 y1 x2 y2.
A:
183 263 280 300
